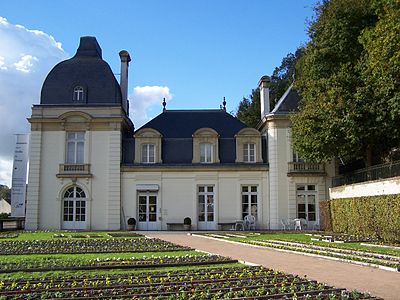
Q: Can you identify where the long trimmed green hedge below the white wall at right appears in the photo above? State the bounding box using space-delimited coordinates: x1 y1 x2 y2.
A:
320 194 400 243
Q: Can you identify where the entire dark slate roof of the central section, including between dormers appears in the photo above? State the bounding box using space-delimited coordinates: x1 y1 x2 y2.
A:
122 109 267 165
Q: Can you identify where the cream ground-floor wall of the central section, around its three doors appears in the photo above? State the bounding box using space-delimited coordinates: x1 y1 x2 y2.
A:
122 170 269 230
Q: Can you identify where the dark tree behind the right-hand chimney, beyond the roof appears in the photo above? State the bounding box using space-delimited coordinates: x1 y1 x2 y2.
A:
236 48 303 127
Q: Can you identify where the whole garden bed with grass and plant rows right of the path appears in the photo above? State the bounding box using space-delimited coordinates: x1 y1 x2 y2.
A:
199 232 400 271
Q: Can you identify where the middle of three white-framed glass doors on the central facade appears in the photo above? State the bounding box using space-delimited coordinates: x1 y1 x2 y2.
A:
198 186 216 230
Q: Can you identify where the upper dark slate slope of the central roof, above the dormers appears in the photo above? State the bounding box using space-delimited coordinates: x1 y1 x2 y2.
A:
139 109 247 138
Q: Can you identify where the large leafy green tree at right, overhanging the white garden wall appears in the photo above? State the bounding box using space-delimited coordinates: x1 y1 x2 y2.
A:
292 0 400 162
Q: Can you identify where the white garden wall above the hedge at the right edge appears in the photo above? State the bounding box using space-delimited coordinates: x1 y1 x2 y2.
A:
329 177 400 199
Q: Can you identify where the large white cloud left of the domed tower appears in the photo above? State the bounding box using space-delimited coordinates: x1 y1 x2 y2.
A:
0 17 68 185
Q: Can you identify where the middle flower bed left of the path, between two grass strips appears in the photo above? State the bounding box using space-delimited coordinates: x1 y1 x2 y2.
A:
0 254 237 273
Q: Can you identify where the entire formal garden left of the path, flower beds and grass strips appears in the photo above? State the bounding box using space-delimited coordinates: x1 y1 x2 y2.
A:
0 232 382 300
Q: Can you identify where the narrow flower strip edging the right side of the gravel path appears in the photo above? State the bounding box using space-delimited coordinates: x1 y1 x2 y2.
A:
206 234 400 271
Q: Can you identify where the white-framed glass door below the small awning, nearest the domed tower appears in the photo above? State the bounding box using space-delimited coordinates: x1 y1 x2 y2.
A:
138 193 159 230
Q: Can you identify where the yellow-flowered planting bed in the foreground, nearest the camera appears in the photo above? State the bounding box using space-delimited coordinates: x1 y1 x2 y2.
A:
0 267 372 300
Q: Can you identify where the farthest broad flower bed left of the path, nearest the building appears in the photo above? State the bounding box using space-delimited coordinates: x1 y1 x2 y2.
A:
0 238 190 255
